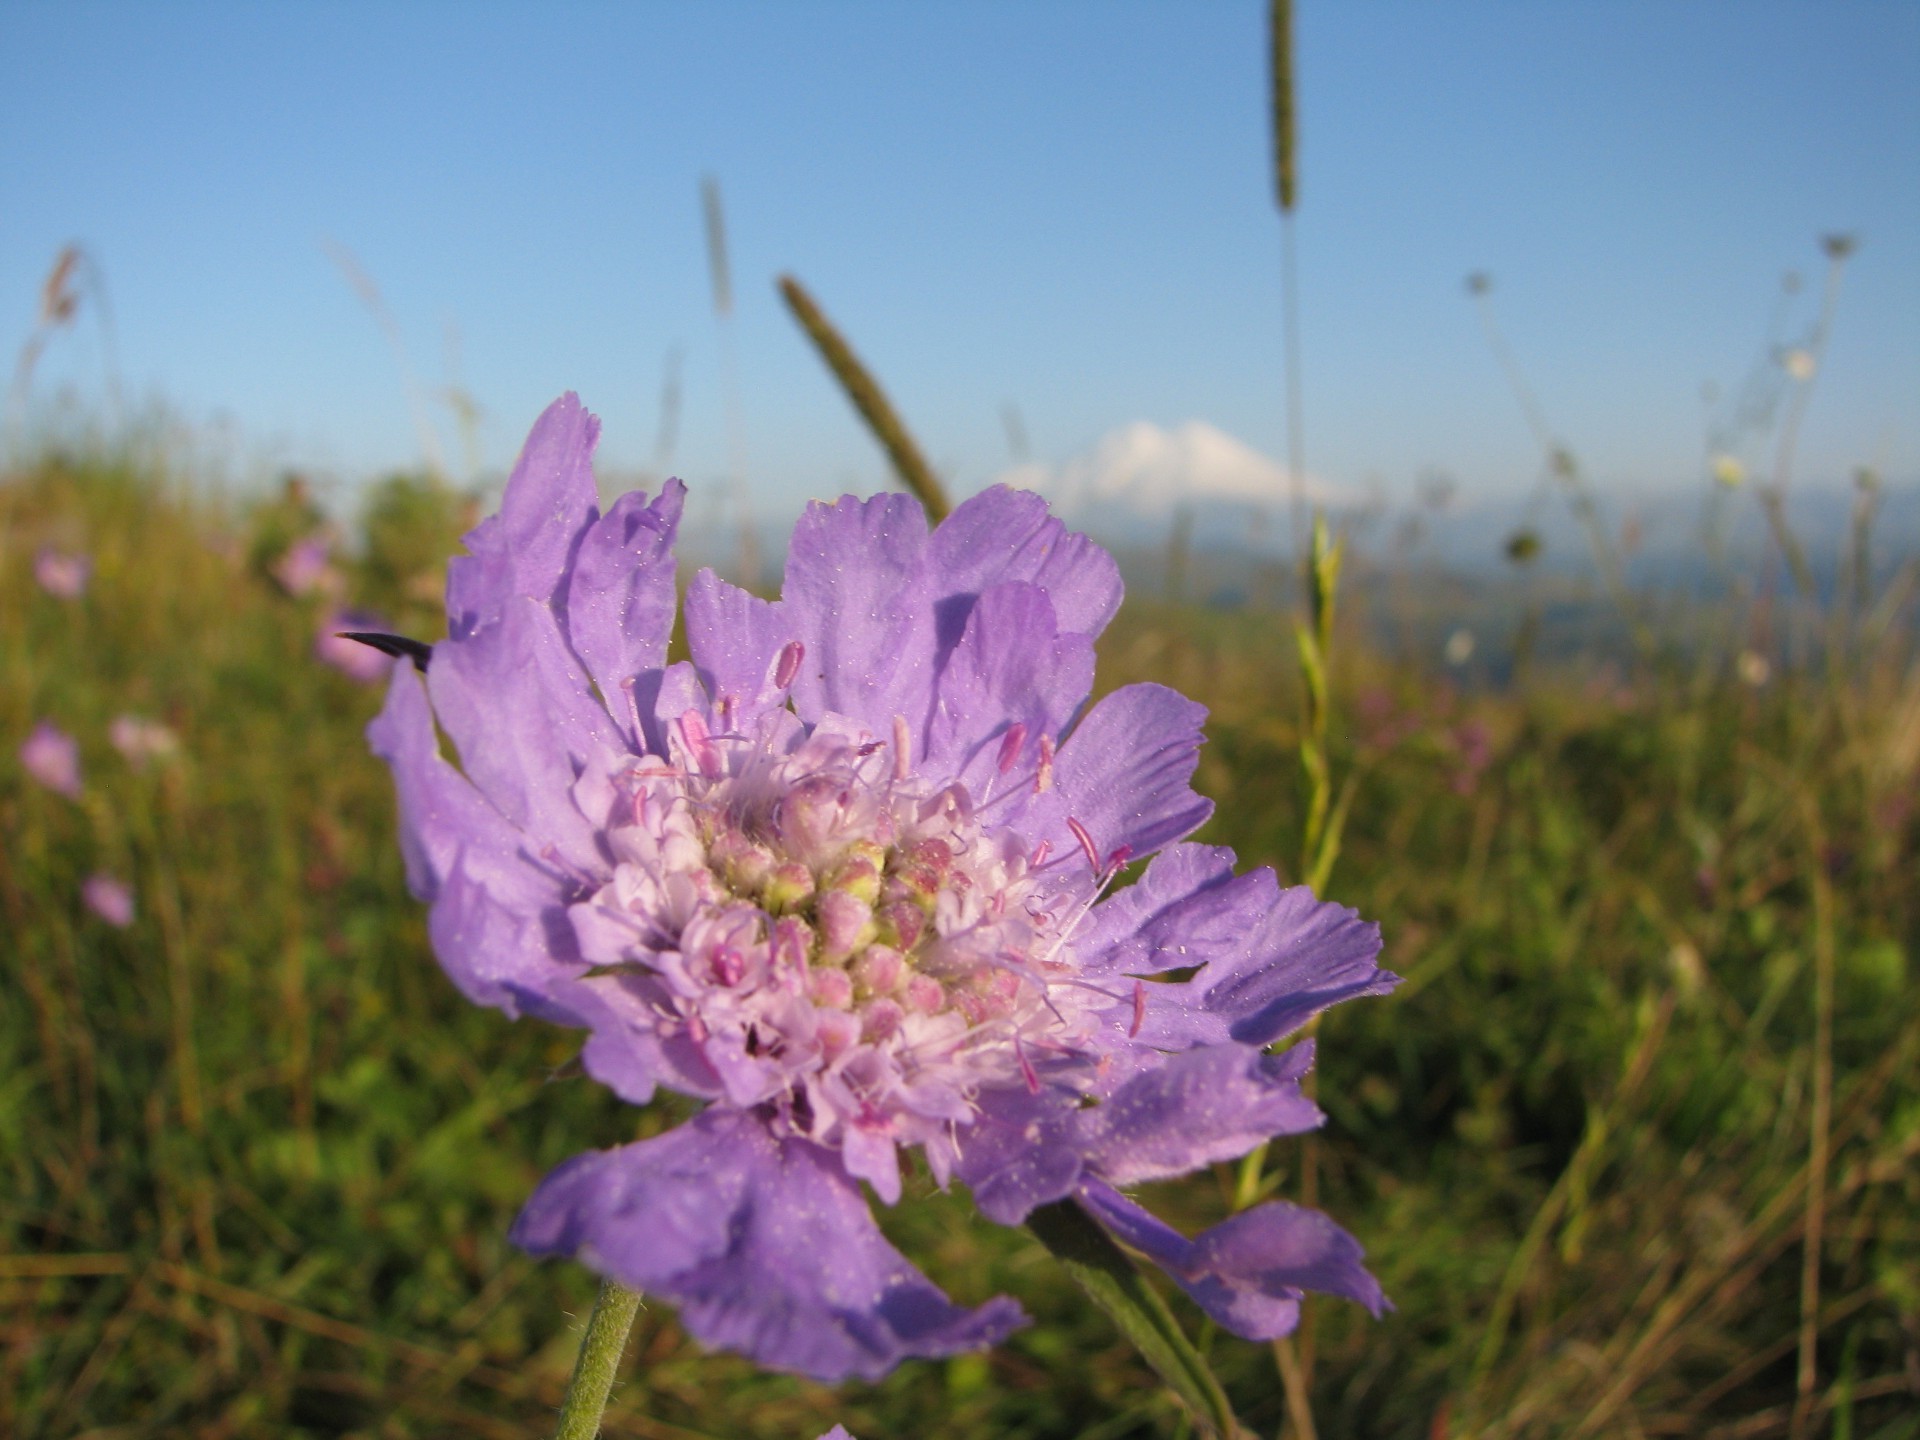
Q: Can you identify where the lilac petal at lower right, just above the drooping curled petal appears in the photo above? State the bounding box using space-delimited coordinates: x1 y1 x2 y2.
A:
1079 1044 1323 1185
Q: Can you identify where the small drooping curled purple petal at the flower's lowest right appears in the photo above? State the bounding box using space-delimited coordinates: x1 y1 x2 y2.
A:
1075 1181 1388 1340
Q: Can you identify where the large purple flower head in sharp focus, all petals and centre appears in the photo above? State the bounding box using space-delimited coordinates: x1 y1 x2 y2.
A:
369 396 1394 1380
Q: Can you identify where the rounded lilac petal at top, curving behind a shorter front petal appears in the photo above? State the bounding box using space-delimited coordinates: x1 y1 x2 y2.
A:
929 486 1121 649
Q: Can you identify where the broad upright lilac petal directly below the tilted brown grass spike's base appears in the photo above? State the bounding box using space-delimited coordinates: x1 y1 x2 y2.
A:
781 495 933 745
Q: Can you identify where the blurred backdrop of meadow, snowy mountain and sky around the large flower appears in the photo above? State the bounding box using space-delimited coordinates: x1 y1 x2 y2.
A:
0 0 1920 1440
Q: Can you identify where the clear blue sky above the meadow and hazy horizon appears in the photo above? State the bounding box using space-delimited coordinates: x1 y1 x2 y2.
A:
0 0 1920 511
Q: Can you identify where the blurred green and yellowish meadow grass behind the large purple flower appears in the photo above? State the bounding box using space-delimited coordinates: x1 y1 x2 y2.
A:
0 445 1920 1440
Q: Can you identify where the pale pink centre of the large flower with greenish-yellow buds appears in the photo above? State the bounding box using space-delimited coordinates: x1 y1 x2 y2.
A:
588 710 1110 1198
